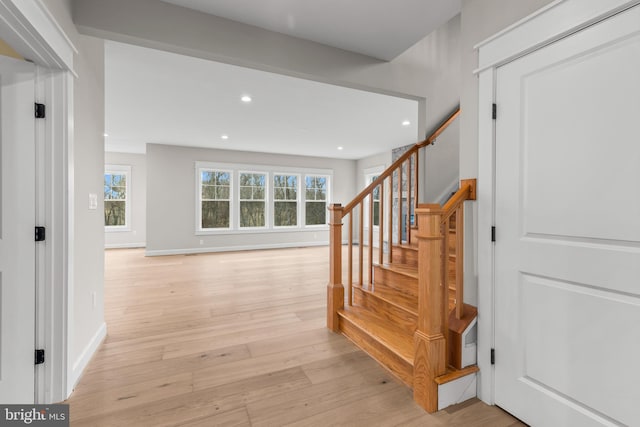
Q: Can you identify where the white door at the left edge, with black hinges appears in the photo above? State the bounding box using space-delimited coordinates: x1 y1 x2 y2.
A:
0 56 35 404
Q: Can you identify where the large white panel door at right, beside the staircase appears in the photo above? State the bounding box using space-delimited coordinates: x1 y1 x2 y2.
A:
495 7 640 427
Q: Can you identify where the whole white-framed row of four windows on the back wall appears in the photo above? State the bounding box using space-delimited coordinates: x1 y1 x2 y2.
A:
194 162 333 235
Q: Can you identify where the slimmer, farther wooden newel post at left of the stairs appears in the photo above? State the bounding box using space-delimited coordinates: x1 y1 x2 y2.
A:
327 203 344 332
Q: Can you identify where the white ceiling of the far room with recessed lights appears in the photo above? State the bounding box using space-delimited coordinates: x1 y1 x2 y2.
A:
105 41 418 159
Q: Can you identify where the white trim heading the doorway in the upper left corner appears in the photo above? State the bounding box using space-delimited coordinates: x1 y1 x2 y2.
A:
0 0 78 72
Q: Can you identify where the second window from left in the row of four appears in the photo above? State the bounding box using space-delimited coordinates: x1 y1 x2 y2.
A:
240 172 267 228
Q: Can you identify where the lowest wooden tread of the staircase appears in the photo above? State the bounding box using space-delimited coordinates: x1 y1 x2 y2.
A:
338 306 413 366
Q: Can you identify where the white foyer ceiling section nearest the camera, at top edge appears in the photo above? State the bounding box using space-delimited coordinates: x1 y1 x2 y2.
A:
162 0 461 61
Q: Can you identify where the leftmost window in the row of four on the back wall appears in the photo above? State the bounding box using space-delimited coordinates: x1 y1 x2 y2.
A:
200 170 231 229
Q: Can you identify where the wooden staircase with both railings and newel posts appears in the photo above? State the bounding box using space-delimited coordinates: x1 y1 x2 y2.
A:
327 110 478 412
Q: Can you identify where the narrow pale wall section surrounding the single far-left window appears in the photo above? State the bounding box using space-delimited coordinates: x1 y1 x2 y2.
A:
104 152 147 248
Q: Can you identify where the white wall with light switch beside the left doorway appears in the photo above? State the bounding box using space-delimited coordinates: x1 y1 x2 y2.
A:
42 0 106 392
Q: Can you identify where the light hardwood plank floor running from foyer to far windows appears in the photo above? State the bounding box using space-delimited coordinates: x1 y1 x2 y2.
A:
68 247 522 427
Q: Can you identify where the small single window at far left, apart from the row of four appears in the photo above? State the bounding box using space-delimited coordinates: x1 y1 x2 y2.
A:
104 165 131 231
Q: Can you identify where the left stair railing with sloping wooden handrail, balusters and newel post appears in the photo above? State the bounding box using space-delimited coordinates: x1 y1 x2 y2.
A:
327 108 460 331
